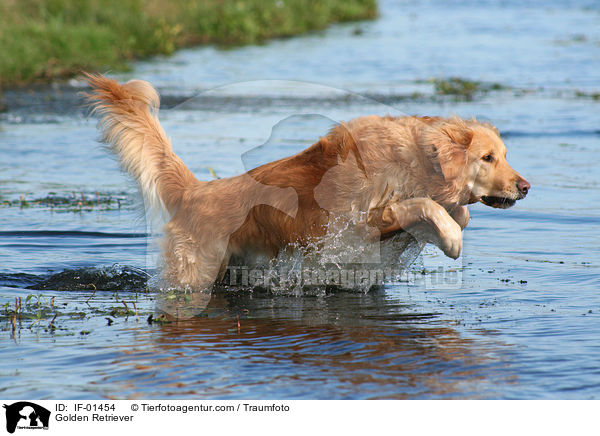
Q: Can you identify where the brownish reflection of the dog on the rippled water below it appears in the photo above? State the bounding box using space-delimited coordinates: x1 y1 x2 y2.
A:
100 292 510 399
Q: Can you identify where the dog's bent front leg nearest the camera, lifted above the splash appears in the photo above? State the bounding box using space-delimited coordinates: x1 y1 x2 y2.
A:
367 198 468 259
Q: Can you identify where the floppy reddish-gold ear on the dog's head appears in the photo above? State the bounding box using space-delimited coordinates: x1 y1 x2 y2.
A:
431 119 473 182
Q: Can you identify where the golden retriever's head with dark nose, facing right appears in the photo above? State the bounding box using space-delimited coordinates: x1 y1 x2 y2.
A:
426 118 531 209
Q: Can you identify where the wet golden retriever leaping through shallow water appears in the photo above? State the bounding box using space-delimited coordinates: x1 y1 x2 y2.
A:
87 75 530 289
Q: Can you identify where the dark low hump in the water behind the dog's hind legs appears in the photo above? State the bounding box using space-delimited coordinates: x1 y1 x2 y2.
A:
27 265 150 291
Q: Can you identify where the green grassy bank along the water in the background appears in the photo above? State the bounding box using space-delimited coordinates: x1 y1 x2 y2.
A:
0 0 376 86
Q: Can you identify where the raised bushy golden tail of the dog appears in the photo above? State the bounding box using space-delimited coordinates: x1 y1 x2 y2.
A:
86 74 199 215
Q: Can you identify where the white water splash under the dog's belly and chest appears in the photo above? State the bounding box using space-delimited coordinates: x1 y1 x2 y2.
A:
223 218 425 296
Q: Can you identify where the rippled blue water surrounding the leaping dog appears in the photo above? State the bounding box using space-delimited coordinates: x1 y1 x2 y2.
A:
0 0 600 399
